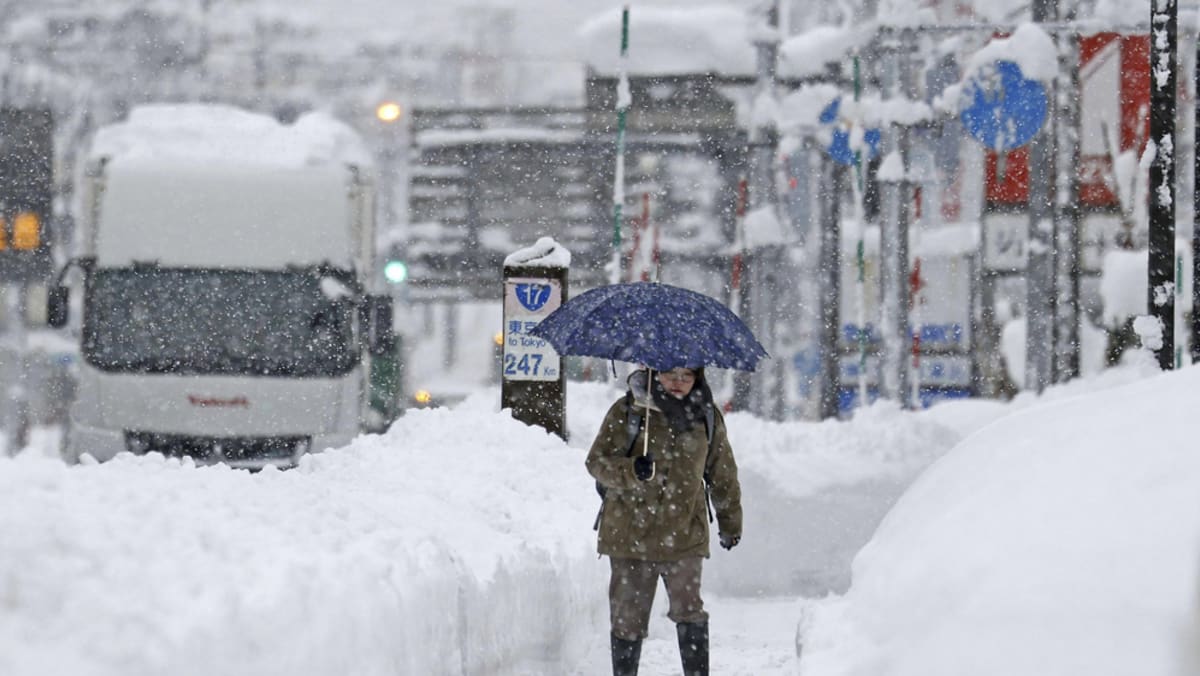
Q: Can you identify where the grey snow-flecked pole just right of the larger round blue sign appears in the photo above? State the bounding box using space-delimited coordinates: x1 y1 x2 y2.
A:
1025 0 1058 393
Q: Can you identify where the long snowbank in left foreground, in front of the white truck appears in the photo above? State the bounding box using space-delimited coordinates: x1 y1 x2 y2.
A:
0 409 607 675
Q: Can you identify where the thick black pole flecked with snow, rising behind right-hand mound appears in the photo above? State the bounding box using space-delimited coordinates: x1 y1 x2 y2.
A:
1147 0 1177 371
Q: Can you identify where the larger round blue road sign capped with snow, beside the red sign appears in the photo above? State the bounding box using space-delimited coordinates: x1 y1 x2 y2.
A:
960 61 1046 152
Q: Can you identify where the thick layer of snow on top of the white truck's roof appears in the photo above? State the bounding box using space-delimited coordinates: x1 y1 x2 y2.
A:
89 103 373 168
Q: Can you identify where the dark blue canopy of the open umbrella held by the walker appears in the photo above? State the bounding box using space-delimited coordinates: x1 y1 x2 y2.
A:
530 282 767 371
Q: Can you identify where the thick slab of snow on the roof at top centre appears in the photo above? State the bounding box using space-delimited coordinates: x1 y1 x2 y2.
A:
578 5 757 77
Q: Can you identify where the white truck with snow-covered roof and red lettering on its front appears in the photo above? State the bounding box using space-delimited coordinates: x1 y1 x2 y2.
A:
48 104 395 467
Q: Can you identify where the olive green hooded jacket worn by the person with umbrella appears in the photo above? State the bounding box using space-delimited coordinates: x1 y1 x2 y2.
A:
587 391 742 561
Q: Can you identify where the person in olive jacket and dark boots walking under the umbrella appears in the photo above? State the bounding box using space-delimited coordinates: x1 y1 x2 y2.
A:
587 369 742 676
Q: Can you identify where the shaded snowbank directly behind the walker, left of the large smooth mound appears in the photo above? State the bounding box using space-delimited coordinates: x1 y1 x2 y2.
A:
704 403 962 597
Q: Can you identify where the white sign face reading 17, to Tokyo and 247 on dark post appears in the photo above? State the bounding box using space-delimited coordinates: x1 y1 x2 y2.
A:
504 277 563 381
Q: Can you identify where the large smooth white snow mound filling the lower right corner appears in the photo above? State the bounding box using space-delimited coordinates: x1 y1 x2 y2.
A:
800 369 1200 676
